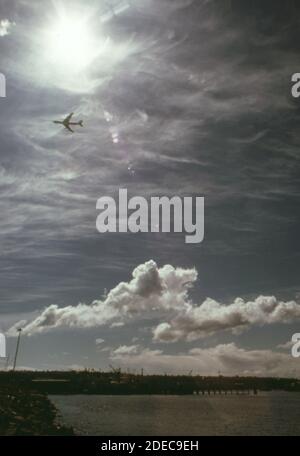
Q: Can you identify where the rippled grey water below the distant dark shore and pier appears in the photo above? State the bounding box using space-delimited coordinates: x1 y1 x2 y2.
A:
50 392 300 436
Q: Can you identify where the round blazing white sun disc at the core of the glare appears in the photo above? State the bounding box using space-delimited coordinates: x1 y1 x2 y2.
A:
45 15 99 74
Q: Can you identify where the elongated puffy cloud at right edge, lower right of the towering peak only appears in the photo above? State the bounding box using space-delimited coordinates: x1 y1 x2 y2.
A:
154 296 300 342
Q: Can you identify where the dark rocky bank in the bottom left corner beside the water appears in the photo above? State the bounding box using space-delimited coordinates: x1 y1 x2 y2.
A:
0 387 74 436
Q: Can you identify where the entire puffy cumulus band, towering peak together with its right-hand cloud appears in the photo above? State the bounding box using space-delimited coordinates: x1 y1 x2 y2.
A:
8 260 300 342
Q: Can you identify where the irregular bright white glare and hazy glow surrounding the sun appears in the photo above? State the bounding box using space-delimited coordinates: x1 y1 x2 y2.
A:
29 0 138 93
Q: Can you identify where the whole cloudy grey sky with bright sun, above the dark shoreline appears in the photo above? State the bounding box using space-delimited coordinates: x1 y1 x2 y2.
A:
0 0 300 376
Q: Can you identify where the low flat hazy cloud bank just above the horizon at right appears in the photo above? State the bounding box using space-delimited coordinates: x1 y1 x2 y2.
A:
111 343 300 376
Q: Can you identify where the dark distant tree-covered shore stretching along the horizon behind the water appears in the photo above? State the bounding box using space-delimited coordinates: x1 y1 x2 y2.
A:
0 369 300 395
